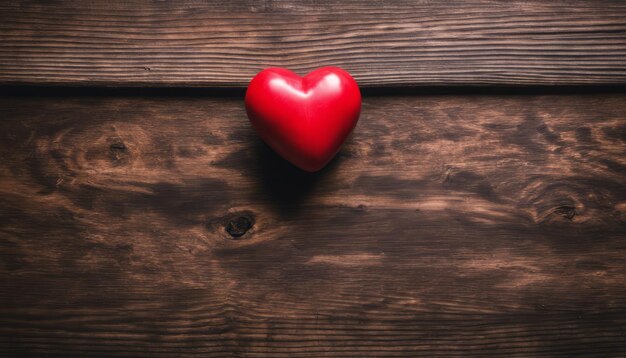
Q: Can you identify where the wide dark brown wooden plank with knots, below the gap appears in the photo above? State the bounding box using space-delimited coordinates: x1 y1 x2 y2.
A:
0 94 626 357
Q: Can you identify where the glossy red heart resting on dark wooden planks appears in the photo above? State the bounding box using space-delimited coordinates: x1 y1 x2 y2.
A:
246 67 361 172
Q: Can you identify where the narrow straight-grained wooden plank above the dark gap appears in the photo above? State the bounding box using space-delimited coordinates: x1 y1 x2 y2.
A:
0 0 626 87
